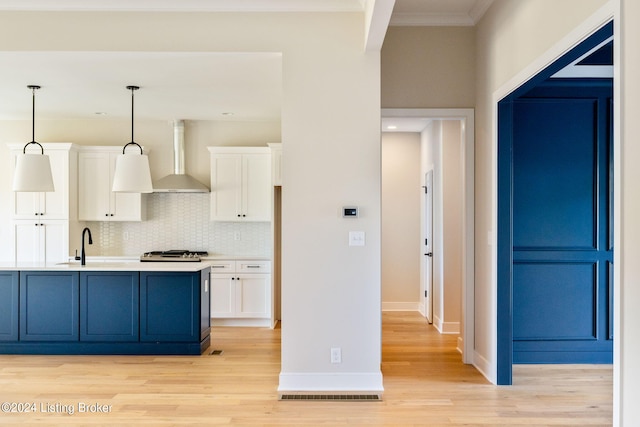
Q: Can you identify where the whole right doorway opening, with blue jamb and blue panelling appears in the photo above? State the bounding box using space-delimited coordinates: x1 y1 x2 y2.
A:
497 22 614 385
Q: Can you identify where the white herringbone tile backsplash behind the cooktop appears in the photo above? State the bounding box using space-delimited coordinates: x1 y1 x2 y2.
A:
88 193 271 257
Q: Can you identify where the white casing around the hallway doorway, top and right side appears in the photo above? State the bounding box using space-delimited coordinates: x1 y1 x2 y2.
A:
381 108 475 364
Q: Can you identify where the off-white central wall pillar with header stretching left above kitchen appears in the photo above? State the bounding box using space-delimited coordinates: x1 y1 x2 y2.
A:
0 12 383 391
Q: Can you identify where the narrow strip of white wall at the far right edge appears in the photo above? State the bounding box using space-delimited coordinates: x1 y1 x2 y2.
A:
614 0 640 427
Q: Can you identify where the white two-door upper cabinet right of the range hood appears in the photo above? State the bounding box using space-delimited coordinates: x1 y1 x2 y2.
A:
209 147 271 221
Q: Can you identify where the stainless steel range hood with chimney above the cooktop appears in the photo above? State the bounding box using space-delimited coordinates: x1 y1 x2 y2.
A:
153 120 209 193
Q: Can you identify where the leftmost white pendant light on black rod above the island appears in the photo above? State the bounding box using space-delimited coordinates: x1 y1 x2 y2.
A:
13 85 55 192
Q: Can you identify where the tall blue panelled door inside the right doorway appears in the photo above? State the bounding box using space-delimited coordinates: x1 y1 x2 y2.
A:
512 95 613 363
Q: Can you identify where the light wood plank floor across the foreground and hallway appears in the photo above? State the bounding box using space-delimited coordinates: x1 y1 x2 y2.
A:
0 312 612 426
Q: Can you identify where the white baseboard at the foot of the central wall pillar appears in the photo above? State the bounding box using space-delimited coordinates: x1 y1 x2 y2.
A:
278 372 384 393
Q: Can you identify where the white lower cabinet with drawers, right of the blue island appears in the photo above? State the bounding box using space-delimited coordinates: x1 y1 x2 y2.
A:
210 260 271 326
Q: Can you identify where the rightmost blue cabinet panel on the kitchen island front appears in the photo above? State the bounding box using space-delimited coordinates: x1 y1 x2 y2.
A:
140 272 200 342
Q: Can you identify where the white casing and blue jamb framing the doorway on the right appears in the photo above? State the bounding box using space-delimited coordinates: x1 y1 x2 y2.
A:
491 10 620 385
